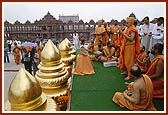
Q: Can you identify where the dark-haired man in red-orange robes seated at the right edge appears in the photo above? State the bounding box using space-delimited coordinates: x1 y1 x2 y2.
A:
146 43 164 98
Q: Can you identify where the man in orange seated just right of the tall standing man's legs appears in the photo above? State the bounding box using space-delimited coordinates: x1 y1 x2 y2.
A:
136 46 150 73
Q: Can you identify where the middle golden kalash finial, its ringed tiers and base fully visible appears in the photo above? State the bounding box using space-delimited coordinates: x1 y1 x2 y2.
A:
35 40 70 110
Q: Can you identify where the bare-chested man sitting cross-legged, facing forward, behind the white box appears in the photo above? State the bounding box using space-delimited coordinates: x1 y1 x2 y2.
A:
100 41 117 62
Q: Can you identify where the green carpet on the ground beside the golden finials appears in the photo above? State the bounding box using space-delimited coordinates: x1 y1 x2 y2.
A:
70 50 164 111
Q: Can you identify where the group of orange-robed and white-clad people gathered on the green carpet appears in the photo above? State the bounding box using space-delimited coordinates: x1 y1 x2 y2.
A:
73 17 164 110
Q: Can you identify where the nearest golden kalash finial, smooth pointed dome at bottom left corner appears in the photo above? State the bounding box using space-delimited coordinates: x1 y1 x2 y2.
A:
5 68 56 111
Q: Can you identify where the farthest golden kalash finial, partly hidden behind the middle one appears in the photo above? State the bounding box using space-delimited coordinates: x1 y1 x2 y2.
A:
59 38 75 73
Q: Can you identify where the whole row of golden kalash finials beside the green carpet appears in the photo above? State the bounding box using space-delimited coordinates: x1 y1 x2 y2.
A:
5 38 76 111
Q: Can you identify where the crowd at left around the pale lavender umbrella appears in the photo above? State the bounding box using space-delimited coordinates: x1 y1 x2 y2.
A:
4 40 44 75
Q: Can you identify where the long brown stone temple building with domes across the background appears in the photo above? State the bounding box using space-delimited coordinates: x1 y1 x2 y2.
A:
4 12 139 42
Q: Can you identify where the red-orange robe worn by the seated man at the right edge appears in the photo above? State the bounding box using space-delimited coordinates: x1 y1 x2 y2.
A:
146 55 164 98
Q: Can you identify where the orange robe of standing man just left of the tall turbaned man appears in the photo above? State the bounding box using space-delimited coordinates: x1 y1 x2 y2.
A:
110 25 121 46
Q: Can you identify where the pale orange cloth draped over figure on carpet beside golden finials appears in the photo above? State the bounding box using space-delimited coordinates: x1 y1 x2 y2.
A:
72 54 95 75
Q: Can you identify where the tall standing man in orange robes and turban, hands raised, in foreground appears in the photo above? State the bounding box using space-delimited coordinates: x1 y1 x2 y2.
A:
119 17 140 80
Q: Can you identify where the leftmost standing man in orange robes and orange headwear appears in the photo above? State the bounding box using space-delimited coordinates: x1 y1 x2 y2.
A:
94 20 105 46
